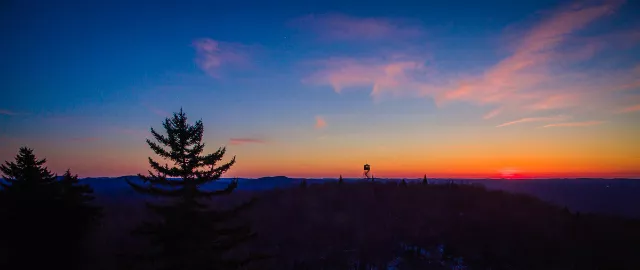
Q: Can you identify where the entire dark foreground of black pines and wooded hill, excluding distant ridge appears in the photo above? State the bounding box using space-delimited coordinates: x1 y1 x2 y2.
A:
0 110 640 270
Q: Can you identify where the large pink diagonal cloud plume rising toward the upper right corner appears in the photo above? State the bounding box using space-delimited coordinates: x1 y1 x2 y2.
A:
439 2 619 110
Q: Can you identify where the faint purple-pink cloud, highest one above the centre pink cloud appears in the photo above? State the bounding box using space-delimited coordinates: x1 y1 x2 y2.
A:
291 14 423 41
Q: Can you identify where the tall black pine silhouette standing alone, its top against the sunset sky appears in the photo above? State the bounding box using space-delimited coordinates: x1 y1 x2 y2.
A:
127 109 254 269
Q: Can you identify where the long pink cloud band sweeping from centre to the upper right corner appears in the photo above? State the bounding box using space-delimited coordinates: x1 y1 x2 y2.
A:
304 2 637 109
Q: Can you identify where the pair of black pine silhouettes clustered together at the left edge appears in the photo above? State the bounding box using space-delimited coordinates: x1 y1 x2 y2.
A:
0 147 101 269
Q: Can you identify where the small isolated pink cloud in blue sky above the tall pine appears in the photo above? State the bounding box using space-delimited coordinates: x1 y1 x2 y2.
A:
193 38 251 78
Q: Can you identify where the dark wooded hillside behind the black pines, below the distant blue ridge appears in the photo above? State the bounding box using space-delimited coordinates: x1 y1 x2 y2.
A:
87 178 640 269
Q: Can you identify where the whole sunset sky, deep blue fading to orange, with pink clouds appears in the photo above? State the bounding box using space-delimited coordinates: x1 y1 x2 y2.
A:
0 0 640 178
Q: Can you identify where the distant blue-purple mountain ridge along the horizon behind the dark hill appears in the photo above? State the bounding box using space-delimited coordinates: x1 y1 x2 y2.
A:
3 176 640 218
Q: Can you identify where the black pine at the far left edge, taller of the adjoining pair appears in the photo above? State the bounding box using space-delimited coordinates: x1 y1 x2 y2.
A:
0 147 57 269
